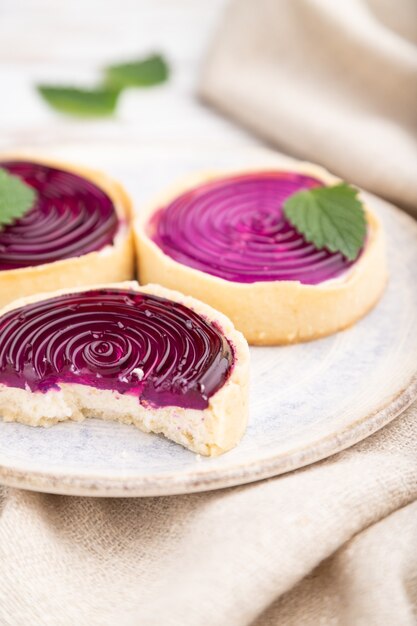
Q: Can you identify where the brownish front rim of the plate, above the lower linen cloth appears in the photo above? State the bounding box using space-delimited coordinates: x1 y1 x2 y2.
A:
0 374 417 498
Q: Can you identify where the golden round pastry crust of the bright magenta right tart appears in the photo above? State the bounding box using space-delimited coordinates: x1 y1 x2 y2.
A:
134 161 387 345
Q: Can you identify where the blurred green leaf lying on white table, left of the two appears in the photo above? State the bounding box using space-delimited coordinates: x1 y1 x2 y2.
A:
37 85 119 117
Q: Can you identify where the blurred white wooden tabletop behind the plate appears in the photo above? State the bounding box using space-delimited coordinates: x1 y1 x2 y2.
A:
0 0 256 150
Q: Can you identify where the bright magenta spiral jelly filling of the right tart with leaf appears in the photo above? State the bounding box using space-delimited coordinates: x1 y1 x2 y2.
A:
147 172 360 285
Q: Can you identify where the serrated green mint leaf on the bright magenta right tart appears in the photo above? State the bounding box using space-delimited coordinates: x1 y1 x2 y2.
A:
284 183 366 261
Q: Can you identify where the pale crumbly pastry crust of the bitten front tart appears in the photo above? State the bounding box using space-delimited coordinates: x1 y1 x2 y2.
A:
0 281 249 456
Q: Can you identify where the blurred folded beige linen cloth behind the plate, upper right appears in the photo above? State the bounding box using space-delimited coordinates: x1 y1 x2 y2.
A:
200 0 417 213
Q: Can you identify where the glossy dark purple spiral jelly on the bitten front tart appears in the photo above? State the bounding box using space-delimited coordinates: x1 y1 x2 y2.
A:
0 289 233 409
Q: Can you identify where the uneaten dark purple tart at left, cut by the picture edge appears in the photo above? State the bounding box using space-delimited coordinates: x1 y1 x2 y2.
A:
0 156 133 306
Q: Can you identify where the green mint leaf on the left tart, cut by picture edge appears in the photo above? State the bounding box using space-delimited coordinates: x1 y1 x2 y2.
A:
0 167 38 228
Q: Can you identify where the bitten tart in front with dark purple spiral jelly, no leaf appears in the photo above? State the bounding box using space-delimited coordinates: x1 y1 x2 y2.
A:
0 282 249 455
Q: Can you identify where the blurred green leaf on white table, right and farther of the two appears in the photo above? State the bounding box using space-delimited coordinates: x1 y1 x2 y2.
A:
104 54 169 89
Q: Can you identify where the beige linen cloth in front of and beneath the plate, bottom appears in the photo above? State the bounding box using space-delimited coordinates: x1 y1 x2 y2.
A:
0 405 417 626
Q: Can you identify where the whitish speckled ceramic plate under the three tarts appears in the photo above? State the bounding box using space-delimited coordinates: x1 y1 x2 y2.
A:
0 144 417 496
